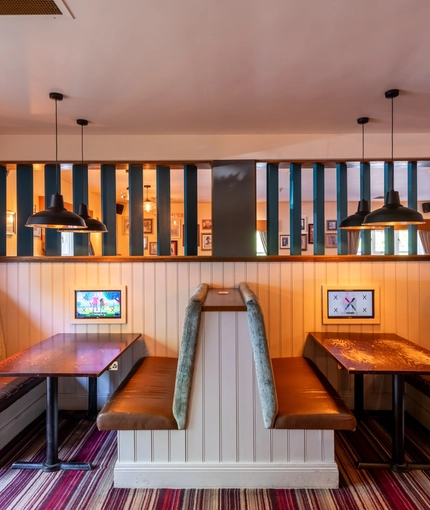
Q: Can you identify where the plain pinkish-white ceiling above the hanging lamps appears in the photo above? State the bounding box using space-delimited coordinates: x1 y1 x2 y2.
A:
0 0 430 203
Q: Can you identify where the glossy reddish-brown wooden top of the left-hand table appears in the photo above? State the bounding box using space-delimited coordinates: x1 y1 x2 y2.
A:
0 333 140 377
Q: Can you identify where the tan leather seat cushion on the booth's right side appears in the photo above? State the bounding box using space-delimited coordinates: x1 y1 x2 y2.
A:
272 357 357 430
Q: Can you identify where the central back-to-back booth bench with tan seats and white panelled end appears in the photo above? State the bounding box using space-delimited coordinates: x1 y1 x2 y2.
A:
97 283 356 488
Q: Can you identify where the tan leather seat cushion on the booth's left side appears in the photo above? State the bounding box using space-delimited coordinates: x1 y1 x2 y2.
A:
97 356 178 430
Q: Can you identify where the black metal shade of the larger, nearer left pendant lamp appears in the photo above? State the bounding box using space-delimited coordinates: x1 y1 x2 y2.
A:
25 193 86 230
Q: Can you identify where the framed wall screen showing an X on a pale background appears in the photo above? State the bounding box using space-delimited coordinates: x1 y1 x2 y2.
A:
322 285 380 324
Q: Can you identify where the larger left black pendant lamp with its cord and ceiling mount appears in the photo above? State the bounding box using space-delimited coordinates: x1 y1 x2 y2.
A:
25 92 86 230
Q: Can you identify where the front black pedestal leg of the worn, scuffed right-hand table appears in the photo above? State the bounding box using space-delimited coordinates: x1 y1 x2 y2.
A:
357 374 430 473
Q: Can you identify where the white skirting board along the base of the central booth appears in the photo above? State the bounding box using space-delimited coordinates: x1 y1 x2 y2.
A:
114 462 339 489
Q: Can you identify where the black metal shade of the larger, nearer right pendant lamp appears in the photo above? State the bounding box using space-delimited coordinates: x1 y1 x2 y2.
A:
363 190 425 228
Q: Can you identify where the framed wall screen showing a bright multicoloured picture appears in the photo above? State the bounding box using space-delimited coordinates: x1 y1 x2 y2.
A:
70 285 127 324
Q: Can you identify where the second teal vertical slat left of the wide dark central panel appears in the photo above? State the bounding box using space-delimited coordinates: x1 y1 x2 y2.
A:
156 165 171 255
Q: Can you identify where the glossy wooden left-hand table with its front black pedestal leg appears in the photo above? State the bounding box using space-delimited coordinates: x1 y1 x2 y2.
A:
0 333 140 472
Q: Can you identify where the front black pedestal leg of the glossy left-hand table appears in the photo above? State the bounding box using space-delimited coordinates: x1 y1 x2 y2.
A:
12 377 92 473
